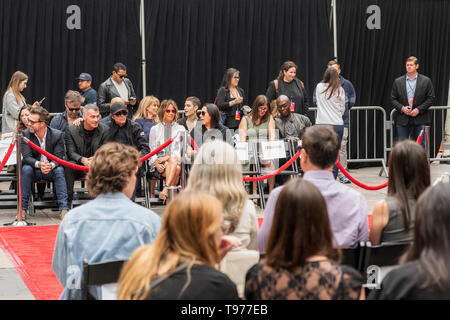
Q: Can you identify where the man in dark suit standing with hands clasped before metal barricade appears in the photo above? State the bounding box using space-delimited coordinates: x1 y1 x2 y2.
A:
391 57 434 141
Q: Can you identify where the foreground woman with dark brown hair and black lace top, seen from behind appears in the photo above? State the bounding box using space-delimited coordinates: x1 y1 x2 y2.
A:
245 179 364 300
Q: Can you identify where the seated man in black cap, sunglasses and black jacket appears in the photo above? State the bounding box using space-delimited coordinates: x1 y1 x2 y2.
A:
107 102 150 156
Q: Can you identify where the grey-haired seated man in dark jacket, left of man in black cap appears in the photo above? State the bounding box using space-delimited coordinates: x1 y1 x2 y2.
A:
65 104 108 207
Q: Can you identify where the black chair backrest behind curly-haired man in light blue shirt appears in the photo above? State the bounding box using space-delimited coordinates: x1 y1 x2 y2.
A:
81 259 126 300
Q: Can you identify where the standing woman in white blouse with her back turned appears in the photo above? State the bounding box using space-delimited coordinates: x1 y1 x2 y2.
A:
315 67 345 178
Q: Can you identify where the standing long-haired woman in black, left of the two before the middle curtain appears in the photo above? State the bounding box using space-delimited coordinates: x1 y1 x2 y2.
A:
215 68 245 129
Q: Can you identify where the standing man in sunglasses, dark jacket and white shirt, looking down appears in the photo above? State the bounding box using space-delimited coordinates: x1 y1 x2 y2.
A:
97 62 137 118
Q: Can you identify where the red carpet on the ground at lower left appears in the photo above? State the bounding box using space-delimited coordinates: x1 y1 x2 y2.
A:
0 226 63 300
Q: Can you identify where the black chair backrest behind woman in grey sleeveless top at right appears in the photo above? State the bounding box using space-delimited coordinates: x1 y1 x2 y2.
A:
364 242 411 270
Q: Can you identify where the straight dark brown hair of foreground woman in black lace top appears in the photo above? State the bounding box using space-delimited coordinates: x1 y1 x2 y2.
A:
266 179 334 269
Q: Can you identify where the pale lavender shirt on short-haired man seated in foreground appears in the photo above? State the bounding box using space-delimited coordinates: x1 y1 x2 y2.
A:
258 170 369 252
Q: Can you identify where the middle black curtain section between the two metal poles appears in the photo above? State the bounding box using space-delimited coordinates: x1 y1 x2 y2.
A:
145 0 333 108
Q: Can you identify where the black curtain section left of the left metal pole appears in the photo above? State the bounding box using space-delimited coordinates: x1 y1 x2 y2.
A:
0 0 142 112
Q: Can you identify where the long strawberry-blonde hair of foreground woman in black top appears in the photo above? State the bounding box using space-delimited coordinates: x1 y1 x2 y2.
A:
117 191 222 300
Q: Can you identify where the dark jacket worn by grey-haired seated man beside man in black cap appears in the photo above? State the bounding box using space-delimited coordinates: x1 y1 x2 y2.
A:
65 123 108 164
